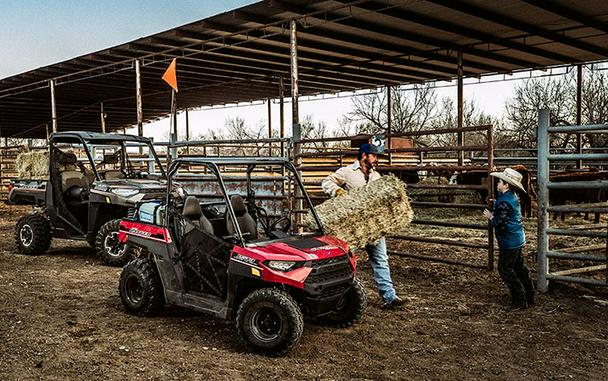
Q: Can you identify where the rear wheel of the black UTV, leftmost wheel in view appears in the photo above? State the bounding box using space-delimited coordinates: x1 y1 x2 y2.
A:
15 213 52 255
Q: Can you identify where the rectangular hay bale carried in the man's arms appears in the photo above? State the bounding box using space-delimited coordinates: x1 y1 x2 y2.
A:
306 175 414 248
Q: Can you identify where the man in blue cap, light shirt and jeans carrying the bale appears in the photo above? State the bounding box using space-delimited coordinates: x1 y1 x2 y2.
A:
321 144 411 309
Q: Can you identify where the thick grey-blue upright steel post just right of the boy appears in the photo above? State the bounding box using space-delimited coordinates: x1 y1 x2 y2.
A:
536 109 549 292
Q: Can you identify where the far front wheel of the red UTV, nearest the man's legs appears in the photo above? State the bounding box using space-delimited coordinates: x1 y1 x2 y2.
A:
324 278 367 328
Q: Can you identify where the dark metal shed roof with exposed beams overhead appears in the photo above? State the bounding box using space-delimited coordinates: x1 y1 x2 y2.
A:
0 0 608 137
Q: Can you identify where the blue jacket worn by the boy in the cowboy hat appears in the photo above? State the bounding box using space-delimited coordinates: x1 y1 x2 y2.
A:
492 190 526 249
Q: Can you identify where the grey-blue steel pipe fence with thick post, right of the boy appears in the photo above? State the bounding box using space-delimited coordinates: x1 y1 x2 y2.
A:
537 109 608 292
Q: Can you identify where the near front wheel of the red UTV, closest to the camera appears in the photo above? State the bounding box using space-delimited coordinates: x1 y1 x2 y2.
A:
236 288 304 356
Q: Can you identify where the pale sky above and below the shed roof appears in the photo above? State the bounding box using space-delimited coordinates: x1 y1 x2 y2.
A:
0 0 536 141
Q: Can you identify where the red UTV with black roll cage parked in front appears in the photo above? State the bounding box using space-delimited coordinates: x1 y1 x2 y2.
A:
119 158 366 355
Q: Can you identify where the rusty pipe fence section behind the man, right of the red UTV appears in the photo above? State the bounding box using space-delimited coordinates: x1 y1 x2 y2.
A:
296 126 494 270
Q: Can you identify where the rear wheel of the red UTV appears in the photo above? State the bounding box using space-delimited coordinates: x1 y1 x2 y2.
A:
118 258 165 316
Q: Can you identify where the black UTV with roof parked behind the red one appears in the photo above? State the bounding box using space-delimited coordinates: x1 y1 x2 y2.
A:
11 131 167 266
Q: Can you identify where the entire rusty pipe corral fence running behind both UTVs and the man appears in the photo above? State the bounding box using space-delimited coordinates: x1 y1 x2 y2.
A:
1 126 494 269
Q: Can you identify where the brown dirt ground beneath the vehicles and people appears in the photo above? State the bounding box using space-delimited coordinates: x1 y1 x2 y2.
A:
0 205 608 381
